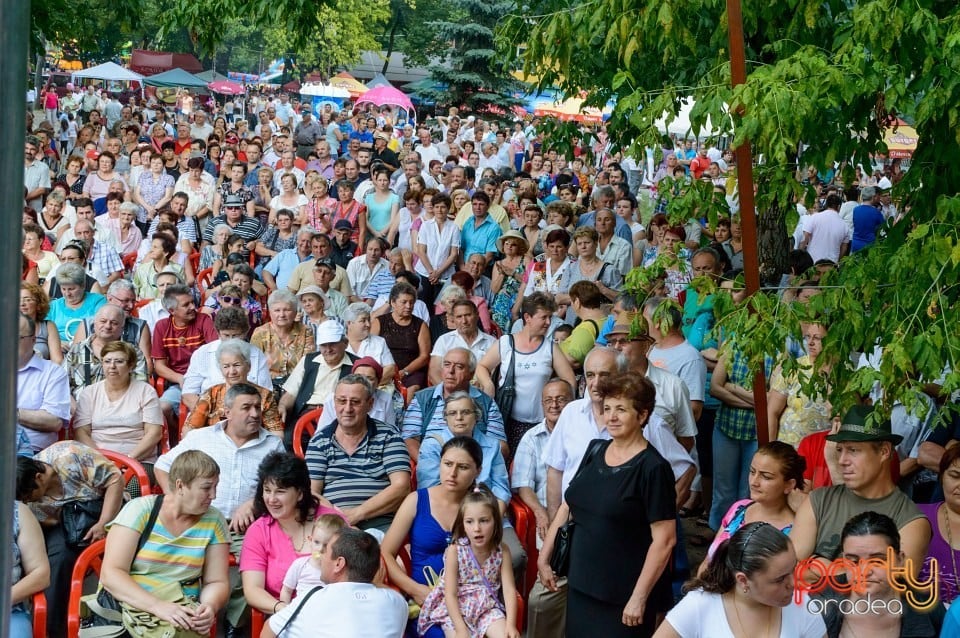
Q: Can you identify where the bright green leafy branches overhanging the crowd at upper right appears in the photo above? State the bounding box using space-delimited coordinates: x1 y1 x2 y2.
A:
506 0 960 424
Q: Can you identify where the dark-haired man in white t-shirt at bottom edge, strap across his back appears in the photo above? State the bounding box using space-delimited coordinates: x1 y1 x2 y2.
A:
260 528 409 638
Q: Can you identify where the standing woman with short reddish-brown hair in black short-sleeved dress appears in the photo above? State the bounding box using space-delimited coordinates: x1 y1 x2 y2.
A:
538 374 677 638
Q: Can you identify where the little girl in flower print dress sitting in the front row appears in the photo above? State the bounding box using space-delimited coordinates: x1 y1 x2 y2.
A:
418 485 520 638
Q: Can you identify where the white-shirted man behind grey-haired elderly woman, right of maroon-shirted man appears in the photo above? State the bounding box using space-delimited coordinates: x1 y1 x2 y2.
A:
180 306 273 410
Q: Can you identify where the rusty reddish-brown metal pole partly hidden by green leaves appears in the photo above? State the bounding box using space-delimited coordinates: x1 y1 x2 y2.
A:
727 0 768 445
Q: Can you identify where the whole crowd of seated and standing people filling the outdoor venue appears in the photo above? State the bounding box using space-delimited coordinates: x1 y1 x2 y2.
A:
12 87 960 638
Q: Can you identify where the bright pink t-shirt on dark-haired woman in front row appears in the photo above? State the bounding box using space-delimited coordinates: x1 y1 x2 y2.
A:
240 507 342 597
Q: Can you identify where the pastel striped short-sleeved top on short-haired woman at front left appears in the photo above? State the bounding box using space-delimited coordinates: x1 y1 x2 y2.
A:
110 496 230 596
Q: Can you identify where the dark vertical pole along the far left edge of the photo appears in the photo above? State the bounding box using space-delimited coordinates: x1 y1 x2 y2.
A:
0 0 32 636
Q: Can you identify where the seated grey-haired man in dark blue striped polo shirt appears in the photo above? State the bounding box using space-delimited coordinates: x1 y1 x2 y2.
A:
306 374 410 532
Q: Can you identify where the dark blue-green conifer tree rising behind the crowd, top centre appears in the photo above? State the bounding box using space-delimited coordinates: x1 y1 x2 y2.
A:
428 0 520 113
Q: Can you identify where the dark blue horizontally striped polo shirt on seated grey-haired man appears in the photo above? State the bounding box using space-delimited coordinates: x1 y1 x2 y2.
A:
306 417 410 509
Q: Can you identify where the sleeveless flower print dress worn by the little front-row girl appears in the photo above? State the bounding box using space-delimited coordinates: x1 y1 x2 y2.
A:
417 538 506 638
